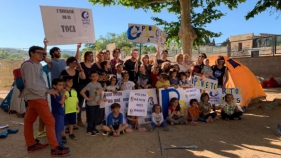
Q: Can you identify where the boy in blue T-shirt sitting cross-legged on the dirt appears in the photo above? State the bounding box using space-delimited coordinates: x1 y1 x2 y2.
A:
102 103 132 137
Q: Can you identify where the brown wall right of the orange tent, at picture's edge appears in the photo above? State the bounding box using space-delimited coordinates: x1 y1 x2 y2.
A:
234 56 281 77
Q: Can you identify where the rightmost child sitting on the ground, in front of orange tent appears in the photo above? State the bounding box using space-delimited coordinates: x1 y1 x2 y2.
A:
221 94 243 120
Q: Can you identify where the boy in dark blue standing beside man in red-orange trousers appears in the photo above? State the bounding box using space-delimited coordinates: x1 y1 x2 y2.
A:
51 78 68 148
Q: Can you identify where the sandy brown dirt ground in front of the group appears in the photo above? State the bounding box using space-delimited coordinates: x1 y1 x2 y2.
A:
0 88 281 158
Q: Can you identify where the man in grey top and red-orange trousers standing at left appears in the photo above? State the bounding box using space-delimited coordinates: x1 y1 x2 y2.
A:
21 46 70 156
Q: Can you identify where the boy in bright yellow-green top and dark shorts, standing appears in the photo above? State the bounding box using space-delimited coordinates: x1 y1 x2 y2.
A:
62 76 80 143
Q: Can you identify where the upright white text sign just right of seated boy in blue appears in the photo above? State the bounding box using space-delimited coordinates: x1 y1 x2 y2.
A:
128 92 148 116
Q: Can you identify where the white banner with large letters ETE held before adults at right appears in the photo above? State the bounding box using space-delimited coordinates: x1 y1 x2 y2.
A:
193 75 218 92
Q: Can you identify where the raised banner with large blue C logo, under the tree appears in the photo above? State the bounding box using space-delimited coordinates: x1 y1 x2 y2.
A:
127 24 167 48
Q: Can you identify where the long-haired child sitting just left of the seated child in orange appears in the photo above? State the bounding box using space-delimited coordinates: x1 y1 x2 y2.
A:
167 97 187 125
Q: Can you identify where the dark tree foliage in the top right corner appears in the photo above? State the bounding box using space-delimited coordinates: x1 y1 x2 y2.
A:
246 0 281 20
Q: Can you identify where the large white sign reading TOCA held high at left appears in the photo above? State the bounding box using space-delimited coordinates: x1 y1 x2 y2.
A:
40 6 95 45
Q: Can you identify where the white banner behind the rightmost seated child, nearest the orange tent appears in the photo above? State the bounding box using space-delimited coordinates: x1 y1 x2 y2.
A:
209 88 242 104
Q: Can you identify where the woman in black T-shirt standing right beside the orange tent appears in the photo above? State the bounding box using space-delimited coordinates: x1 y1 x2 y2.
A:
212 56 228 88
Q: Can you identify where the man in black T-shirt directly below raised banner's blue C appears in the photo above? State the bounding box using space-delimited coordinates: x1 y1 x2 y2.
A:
124 49 141 82
